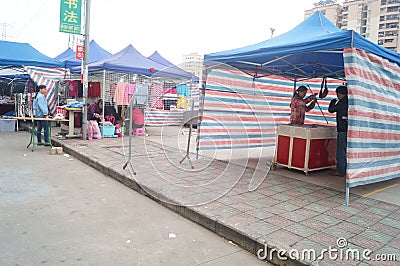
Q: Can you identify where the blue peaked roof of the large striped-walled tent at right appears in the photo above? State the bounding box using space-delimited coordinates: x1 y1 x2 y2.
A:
204 11 400 78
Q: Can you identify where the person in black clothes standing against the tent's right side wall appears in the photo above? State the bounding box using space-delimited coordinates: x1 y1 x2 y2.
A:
328 86 349 176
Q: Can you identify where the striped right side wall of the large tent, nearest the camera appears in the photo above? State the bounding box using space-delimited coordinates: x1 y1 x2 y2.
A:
344 48 400 187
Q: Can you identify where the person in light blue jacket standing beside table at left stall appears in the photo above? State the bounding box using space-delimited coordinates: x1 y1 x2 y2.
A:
33 85 50 146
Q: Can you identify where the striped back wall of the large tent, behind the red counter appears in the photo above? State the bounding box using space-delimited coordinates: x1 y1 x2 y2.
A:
197 69 342 150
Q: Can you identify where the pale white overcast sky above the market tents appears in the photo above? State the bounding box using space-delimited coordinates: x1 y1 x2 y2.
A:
0 0 324 65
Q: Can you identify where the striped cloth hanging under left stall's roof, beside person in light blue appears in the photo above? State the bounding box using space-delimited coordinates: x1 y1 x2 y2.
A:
25 66 70 114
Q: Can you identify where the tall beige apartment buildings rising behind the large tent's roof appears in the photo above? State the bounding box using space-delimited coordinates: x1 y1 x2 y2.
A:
304 0 400 53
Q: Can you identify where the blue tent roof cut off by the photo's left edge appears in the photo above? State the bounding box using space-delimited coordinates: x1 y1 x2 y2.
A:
0 41 63 67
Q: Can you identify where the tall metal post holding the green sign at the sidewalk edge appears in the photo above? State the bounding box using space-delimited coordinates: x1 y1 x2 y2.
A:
82 0 90 140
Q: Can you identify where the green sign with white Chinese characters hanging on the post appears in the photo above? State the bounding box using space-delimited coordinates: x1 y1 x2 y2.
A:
60 0 82 34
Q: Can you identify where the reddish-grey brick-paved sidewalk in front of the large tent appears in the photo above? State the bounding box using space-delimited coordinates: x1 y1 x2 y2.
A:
47 131 400 265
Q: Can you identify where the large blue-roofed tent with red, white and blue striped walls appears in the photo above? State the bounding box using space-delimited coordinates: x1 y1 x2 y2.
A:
203 11 400 203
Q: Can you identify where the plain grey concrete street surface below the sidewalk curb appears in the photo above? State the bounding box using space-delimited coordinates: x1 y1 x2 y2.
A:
0 132 269 265
